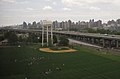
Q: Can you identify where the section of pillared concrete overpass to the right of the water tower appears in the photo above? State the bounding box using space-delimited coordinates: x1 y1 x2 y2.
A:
54 31 120 48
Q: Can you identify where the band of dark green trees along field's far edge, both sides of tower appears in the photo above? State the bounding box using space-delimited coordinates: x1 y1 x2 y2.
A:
0 31 69 46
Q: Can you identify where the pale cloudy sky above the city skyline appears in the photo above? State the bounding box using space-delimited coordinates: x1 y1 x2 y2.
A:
0 0 120 26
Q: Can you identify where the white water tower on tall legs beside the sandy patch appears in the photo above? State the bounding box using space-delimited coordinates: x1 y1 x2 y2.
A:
41 20 53 46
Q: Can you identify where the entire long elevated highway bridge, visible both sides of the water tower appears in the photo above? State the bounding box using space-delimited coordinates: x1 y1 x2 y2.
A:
0 29 120 48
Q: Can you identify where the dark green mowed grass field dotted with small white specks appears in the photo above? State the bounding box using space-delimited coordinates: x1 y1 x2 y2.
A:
0 46 120 79
